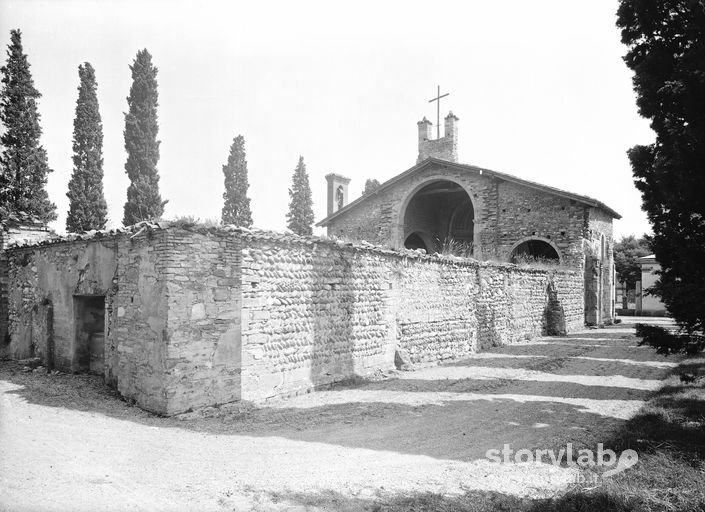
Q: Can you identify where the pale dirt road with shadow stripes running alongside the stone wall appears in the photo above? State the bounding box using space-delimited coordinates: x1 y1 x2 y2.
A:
0 318 676 511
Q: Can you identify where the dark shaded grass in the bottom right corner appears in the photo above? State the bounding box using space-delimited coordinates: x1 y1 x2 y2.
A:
264 358 705 512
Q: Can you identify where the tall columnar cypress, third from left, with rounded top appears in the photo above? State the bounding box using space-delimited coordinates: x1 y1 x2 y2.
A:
123 50 167 226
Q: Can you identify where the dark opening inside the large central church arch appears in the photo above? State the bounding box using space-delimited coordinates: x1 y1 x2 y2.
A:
404 180 475 256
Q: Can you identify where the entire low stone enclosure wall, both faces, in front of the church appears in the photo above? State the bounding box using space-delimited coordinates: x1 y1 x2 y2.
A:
6 224 584 415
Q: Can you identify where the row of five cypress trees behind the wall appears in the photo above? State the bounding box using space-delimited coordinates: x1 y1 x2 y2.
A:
0 30 313 235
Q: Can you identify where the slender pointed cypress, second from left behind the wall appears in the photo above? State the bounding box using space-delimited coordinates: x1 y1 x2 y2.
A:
66 62 108 233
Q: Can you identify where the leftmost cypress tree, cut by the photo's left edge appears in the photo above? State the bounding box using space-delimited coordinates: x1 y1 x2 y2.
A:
0 30 56 222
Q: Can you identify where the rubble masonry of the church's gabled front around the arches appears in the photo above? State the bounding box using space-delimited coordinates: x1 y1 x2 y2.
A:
327 162 612 268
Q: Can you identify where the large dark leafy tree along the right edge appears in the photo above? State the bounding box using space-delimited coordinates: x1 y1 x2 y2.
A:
617 0 705 350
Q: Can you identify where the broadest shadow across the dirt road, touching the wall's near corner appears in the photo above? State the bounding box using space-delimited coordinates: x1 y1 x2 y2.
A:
0 358 640 461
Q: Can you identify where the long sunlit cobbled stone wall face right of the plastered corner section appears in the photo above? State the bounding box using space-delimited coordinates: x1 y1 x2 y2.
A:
236 233 584 401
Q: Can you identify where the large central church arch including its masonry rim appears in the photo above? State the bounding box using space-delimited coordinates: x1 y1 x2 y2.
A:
393 176 479 257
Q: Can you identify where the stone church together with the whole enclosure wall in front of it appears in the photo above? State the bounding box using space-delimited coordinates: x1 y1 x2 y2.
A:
0 114 619 415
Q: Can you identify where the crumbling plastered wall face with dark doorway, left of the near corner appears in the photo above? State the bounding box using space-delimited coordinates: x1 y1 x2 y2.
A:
6 232 167 413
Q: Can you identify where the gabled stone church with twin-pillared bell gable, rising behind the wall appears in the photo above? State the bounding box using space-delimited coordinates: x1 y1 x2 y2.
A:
318 112 621 325
